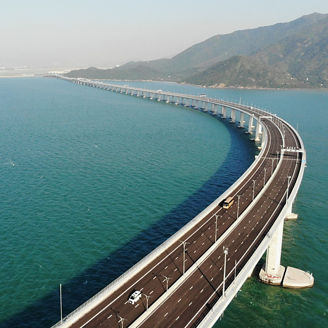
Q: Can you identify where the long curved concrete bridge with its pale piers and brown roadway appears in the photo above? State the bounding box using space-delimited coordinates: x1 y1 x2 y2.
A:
48 76 314 328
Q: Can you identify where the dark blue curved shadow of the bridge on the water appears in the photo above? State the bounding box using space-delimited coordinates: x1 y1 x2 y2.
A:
0 117 256 328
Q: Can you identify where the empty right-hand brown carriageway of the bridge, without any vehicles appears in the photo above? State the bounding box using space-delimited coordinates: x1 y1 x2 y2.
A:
142 120 297 327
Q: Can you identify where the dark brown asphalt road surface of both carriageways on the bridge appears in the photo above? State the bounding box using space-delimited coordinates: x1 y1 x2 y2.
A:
71 109 301 328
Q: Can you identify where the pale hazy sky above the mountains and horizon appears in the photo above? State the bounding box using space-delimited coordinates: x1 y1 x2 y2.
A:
0 0 328 67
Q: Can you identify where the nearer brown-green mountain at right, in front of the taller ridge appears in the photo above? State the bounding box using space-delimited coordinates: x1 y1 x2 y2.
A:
185 17 328 88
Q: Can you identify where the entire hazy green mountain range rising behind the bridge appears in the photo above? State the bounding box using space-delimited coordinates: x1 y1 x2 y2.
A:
67 13 328 88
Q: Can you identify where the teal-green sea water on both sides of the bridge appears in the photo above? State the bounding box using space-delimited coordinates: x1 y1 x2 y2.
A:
0 78 328 328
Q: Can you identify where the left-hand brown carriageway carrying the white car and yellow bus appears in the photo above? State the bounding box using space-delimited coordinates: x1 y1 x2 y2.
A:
70 114 284 327
